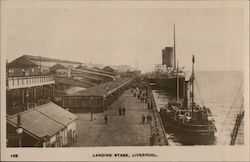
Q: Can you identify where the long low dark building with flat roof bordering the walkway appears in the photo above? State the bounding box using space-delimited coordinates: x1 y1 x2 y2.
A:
62 78 133 112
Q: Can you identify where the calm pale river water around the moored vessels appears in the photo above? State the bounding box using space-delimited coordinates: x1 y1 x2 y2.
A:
153 72 244 145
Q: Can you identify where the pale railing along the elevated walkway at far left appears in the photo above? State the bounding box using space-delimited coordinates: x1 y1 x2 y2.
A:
6 75 55 90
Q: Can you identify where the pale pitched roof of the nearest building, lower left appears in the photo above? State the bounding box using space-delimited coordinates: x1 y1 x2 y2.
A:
7 102 77 138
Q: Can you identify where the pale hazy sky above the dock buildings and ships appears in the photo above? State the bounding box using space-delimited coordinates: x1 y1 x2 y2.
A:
3 1 248 72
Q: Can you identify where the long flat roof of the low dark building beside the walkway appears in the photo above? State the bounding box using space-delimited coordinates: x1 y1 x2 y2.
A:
68 78 130 96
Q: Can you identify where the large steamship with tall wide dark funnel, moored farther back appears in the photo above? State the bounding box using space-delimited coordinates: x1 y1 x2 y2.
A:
149 27 185 97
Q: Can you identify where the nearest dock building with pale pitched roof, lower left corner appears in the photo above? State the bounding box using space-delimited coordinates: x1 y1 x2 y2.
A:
7 102 78 147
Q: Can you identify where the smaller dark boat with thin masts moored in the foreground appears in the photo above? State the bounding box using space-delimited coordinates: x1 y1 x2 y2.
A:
160 56 216 136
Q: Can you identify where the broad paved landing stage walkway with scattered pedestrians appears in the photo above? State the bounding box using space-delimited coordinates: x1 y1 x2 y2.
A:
73 89 152 147
